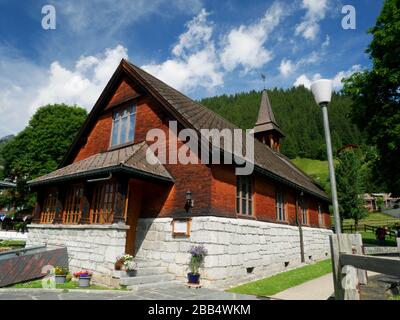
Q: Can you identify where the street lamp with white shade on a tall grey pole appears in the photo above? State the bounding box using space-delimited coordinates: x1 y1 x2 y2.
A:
311 79 341 234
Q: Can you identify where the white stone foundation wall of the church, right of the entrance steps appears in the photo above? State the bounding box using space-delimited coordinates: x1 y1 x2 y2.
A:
136 217 332 288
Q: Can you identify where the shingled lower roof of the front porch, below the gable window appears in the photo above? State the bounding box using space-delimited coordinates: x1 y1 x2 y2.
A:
29 142 173 186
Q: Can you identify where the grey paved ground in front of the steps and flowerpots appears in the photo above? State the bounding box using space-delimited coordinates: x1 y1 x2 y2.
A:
0 285 259 300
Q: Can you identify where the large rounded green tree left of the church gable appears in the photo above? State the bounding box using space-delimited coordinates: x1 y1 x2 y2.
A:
2 104 87 207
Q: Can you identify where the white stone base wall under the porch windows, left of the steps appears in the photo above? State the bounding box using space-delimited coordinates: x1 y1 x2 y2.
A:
26 224 129 285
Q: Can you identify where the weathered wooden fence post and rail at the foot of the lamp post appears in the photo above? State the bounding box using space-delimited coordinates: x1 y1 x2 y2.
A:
330 233 400 300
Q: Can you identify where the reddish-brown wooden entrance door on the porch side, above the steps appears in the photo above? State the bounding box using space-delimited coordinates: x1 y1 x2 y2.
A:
125 180 143 256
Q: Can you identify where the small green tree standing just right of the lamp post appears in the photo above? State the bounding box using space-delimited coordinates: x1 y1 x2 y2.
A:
335 150 368 227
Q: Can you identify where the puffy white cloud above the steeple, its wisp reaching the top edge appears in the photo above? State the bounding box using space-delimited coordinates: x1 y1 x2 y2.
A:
221 2 288 72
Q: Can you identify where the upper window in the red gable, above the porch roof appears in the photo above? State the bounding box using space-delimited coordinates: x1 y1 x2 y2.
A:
111 106 136 147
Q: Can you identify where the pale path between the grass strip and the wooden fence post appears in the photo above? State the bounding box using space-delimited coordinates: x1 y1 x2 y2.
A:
271 273 334 300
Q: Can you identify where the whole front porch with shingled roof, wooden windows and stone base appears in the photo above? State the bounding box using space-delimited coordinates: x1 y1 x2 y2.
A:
27 143 173 284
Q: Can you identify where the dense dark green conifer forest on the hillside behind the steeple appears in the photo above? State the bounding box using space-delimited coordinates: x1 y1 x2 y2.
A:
199 86 365 160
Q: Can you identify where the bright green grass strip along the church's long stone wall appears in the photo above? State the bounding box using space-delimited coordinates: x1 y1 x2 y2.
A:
228 259 332 296
